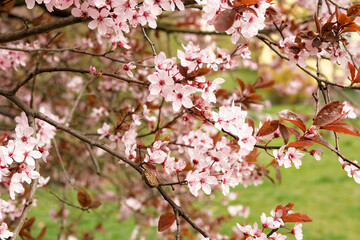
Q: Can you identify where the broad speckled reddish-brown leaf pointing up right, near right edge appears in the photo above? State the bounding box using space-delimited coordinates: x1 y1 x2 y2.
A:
314 101 344 127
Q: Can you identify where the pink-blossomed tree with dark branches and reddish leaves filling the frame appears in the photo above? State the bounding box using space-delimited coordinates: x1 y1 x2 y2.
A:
0 0 360 239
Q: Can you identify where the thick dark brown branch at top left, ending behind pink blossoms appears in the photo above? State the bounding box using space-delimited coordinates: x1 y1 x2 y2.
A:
0 16 87 43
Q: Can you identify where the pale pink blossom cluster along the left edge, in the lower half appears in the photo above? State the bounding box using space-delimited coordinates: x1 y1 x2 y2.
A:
0 112 56 239
